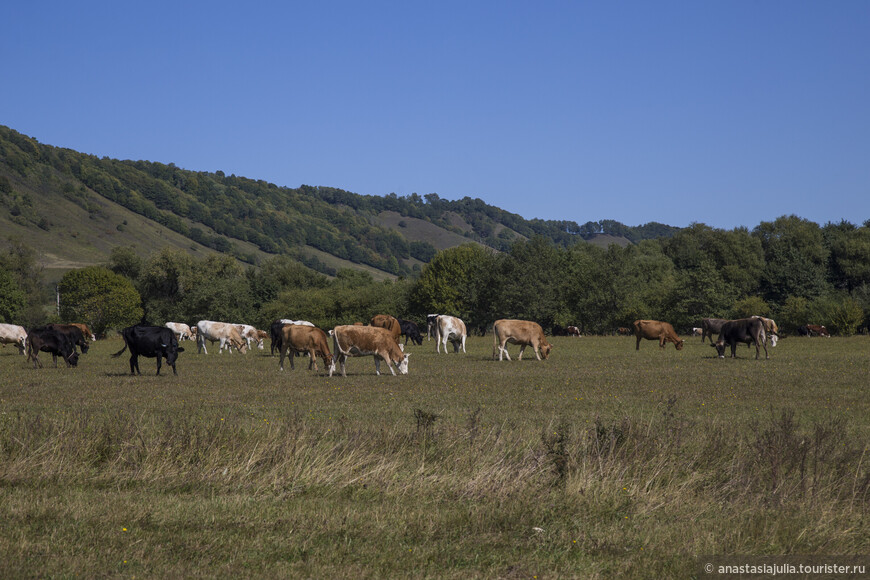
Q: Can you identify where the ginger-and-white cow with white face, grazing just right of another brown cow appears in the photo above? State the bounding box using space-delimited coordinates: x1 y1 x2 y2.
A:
329 324 411 377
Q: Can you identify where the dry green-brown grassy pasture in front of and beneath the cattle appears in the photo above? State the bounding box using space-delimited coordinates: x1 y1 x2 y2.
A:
0 337 870 578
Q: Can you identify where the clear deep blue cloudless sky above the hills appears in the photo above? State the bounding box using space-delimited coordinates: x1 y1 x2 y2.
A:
0 0 870 229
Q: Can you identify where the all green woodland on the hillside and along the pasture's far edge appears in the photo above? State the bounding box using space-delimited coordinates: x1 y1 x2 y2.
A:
0 127 870 335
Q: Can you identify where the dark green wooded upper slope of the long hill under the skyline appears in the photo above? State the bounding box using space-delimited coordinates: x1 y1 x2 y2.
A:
0 126 677 275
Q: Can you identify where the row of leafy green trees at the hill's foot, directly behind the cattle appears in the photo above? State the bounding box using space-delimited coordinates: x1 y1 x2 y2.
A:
0 216 870 335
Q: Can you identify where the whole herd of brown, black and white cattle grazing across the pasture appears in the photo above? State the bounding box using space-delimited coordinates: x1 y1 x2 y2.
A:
0 314 830 376
